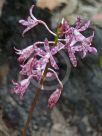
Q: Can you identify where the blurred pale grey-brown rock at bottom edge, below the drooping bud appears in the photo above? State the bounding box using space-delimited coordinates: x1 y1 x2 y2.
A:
51 108 79 136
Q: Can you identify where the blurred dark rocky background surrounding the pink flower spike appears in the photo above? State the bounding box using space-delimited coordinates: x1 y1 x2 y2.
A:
0 0 102 136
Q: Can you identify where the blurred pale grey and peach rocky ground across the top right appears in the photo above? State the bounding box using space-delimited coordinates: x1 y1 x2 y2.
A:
37 0 102 28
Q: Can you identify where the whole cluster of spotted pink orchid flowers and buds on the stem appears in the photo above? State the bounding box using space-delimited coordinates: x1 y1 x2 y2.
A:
12 6 97 108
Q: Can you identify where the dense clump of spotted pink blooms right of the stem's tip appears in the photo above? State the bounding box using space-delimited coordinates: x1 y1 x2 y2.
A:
62 17 97 67
